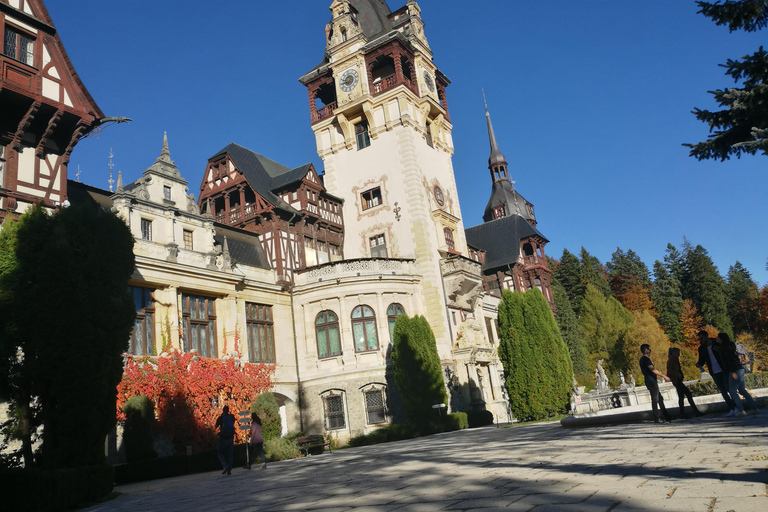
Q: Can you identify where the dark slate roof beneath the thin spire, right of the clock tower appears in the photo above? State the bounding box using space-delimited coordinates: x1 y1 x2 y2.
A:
464 215 549 270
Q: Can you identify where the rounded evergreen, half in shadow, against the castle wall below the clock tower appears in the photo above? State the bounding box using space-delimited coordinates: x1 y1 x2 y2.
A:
392 315 448 425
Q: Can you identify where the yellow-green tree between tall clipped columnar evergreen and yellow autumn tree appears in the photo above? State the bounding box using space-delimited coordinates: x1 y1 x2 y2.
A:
579 285 632 373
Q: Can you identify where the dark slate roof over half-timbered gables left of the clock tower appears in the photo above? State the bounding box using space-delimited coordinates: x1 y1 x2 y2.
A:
210 142 309 214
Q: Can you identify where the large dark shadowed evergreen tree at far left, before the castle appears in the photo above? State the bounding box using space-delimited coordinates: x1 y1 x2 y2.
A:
0 206 136 467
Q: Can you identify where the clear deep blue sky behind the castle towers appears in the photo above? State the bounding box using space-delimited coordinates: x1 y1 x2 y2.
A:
46 0 768 284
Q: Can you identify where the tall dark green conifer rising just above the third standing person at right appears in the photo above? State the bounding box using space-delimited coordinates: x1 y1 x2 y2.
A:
682 245 732 335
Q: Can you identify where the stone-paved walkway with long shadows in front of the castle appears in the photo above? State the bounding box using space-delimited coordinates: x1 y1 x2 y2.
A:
82 410 768 512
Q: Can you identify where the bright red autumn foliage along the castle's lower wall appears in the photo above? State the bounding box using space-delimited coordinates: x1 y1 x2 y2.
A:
117 348 275 451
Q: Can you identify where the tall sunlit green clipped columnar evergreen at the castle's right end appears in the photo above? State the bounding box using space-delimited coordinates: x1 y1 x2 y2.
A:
499 289 573 421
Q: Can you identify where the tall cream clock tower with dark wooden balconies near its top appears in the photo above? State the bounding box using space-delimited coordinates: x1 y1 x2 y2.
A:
300 0 468 359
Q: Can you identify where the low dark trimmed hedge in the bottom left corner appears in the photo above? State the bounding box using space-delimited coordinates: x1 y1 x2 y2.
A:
0 465 114 512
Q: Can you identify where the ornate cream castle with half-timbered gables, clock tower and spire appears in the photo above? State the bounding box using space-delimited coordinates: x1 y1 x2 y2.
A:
0 0 553 442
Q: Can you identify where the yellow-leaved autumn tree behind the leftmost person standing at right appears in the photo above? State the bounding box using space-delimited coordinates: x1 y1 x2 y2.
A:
624 311 671 385
